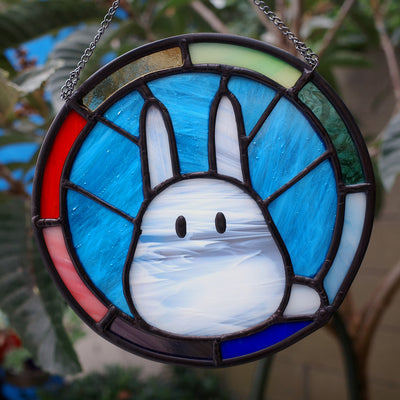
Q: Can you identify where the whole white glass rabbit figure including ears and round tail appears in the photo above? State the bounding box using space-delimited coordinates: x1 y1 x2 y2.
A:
128 96 320 336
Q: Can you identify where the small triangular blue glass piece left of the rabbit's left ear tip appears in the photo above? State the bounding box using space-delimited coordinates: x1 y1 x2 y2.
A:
104 91 144 137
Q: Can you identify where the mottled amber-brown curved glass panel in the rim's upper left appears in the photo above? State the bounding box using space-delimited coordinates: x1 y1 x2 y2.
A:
83 47 183 110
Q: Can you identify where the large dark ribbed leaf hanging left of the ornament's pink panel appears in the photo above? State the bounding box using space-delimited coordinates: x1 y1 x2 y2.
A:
0 194 80 374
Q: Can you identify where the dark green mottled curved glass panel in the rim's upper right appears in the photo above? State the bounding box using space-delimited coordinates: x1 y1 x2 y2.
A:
299 83 365 185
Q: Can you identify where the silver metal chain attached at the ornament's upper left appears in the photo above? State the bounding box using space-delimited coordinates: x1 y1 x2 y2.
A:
61 0 119 100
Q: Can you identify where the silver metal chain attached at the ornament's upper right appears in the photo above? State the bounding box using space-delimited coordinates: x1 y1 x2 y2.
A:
253 0 319 69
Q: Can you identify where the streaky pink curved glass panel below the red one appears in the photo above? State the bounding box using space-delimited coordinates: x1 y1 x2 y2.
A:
43 226 108 322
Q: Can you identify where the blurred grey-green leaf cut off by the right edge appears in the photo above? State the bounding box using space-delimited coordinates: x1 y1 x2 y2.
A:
378 113 400 191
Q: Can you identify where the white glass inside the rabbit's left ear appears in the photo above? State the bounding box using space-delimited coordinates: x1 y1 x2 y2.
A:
145 104 176 189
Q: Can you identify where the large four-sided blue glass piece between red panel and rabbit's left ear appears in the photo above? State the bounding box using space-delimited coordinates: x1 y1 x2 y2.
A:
70 123 143 217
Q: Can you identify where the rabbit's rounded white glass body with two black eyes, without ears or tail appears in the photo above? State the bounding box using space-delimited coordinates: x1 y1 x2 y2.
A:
130 178 286 336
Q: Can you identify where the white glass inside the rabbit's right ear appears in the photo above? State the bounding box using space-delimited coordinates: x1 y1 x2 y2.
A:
214 96 244 182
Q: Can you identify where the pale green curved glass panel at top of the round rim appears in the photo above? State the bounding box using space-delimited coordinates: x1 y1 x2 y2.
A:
189 43 301 88
